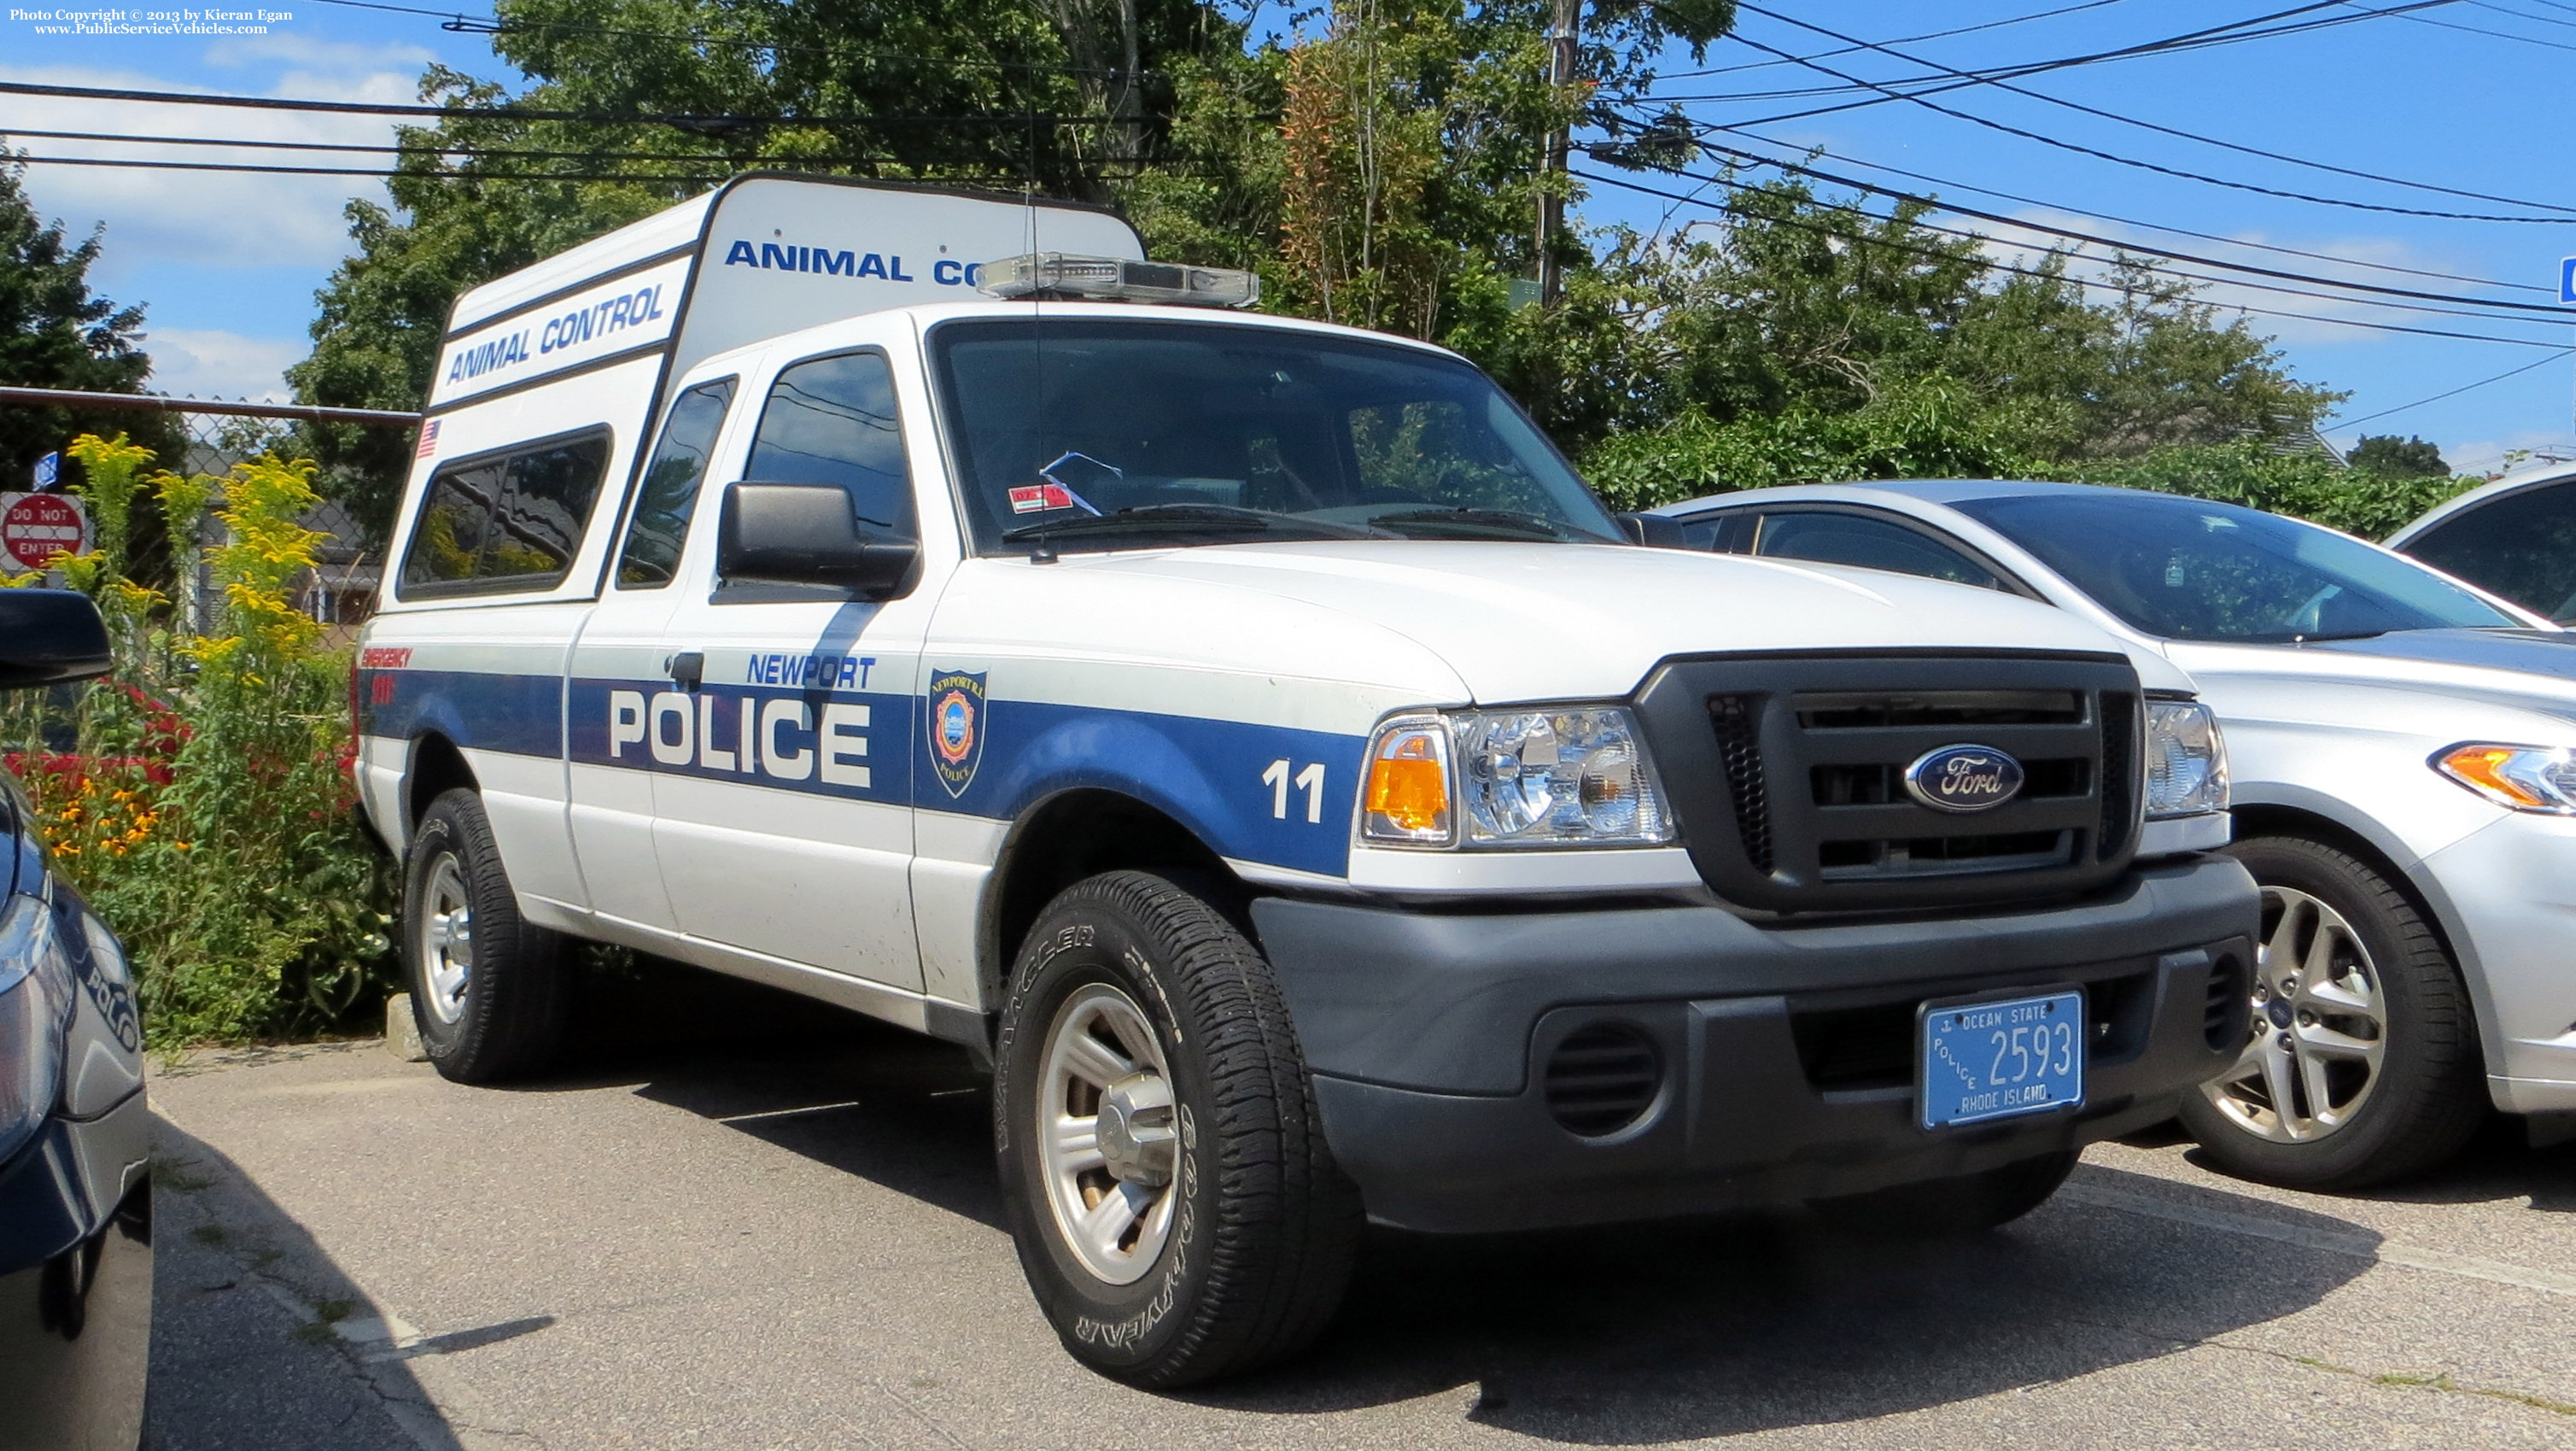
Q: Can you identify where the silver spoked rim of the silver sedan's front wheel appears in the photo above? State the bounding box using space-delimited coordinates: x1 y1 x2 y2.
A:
2203 884 2388 1144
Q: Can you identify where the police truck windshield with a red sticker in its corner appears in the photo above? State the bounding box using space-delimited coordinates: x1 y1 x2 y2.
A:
930 317 1623 554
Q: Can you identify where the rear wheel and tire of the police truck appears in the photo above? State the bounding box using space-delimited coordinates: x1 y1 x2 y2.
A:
402 788 567 1082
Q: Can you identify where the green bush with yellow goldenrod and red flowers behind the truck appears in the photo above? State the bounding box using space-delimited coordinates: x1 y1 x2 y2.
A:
0 438 392 1049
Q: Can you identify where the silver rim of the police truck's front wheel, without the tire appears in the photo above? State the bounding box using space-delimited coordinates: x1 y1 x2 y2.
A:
1036 982 1180 1284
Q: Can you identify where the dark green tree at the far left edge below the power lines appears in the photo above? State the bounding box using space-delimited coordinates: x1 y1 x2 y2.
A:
0 147 170 489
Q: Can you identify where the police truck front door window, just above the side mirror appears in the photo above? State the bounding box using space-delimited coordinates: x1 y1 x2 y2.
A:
742 353 912 539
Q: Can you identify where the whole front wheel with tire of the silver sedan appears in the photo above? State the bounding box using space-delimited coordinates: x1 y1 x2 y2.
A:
2182 838 2485 1188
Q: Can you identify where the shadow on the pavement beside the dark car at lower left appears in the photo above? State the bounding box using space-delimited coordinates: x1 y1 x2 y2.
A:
144 1119 492 1451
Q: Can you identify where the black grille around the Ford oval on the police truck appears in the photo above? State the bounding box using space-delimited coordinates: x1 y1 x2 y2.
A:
1638 655 2141 912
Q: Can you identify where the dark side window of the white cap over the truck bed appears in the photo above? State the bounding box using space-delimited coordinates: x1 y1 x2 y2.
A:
402 433 608 598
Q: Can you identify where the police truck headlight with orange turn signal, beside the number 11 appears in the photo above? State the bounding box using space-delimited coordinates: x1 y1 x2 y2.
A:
1360 706 1674 848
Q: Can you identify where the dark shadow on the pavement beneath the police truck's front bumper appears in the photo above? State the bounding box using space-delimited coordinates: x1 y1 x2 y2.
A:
1190 1167 2375 1446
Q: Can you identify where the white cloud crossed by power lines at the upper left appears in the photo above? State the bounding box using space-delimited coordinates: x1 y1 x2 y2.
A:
0 55 412 268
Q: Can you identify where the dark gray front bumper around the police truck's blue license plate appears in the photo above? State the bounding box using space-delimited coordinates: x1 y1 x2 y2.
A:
1252 856 2259 1229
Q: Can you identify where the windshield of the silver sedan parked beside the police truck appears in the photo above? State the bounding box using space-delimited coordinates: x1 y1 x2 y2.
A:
1953 489 2520 644
